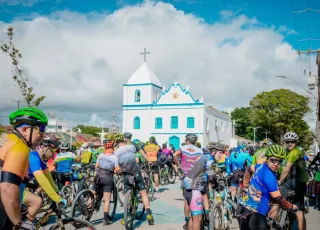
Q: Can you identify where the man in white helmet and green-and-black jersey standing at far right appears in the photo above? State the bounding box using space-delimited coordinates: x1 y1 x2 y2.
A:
279 132 309 230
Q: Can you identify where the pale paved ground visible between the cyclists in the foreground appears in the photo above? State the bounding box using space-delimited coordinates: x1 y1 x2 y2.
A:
85 183 320 230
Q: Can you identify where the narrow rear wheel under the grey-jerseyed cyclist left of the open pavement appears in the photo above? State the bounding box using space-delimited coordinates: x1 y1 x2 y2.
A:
123 190 136 230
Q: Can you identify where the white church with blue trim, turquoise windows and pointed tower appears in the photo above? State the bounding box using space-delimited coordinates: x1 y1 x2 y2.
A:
122 62 232 149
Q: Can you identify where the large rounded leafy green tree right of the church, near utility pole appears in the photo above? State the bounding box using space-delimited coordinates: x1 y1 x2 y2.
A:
249 89 311 145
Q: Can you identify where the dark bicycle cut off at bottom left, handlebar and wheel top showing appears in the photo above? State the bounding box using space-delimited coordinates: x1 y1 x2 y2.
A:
22 202 96 230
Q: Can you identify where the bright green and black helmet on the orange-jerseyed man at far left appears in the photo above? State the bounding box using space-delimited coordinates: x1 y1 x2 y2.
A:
9 107 48 127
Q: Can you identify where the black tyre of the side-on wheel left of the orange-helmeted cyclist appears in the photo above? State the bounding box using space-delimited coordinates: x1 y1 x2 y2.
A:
70 189 95 221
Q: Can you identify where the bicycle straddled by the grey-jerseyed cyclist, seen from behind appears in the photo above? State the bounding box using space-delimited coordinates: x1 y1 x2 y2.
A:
123 175 145 230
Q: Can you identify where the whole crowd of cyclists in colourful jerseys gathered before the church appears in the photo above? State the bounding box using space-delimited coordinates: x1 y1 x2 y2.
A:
0 108 320 230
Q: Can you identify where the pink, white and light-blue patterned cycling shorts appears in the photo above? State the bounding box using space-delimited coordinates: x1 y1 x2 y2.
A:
183 189 203 216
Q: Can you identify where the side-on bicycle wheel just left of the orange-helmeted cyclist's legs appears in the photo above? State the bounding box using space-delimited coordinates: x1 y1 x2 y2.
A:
70 189 95 221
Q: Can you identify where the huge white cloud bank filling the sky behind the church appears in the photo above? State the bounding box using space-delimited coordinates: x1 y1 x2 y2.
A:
0 2 316 129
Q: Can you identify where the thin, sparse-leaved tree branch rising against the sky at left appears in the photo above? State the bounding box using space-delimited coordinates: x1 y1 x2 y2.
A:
1 26 45 107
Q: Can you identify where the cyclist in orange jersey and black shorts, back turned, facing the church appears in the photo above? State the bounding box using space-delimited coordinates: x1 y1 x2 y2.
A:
143 136 161 193
